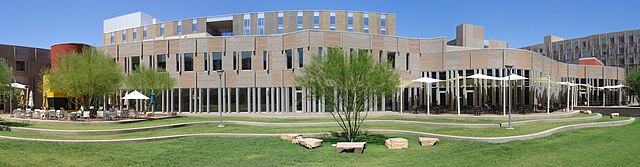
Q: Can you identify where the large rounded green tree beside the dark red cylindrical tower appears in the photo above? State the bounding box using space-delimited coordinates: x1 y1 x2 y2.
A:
43 47 124 107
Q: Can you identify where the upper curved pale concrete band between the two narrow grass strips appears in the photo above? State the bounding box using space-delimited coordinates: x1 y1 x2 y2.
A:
0 114 602 135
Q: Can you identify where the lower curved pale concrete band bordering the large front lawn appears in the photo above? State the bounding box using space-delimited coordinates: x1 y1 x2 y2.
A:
0 118 635 143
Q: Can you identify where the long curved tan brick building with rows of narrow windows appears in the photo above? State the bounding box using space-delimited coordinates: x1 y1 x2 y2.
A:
102 10 626 113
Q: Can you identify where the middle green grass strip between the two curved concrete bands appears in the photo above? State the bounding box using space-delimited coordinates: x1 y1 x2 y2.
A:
0 118 628 140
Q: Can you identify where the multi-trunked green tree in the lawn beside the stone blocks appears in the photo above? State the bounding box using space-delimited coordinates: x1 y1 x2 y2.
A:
296 48 400 142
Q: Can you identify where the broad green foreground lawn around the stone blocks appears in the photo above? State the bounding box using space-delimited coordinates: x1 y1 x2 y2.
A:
0 119 640 166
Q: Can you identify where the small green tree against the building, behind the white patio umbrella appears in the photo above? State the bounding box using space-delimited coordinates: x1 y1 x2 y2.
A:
125 66 176 112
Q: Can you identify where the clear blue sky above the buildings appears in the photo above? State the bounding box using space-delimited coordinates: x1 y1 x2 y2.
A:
0 0 640 48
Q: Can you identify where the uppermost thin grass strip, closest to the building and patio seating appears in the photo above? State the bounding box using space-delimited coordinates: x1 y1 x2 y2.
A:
0 114 593 130
